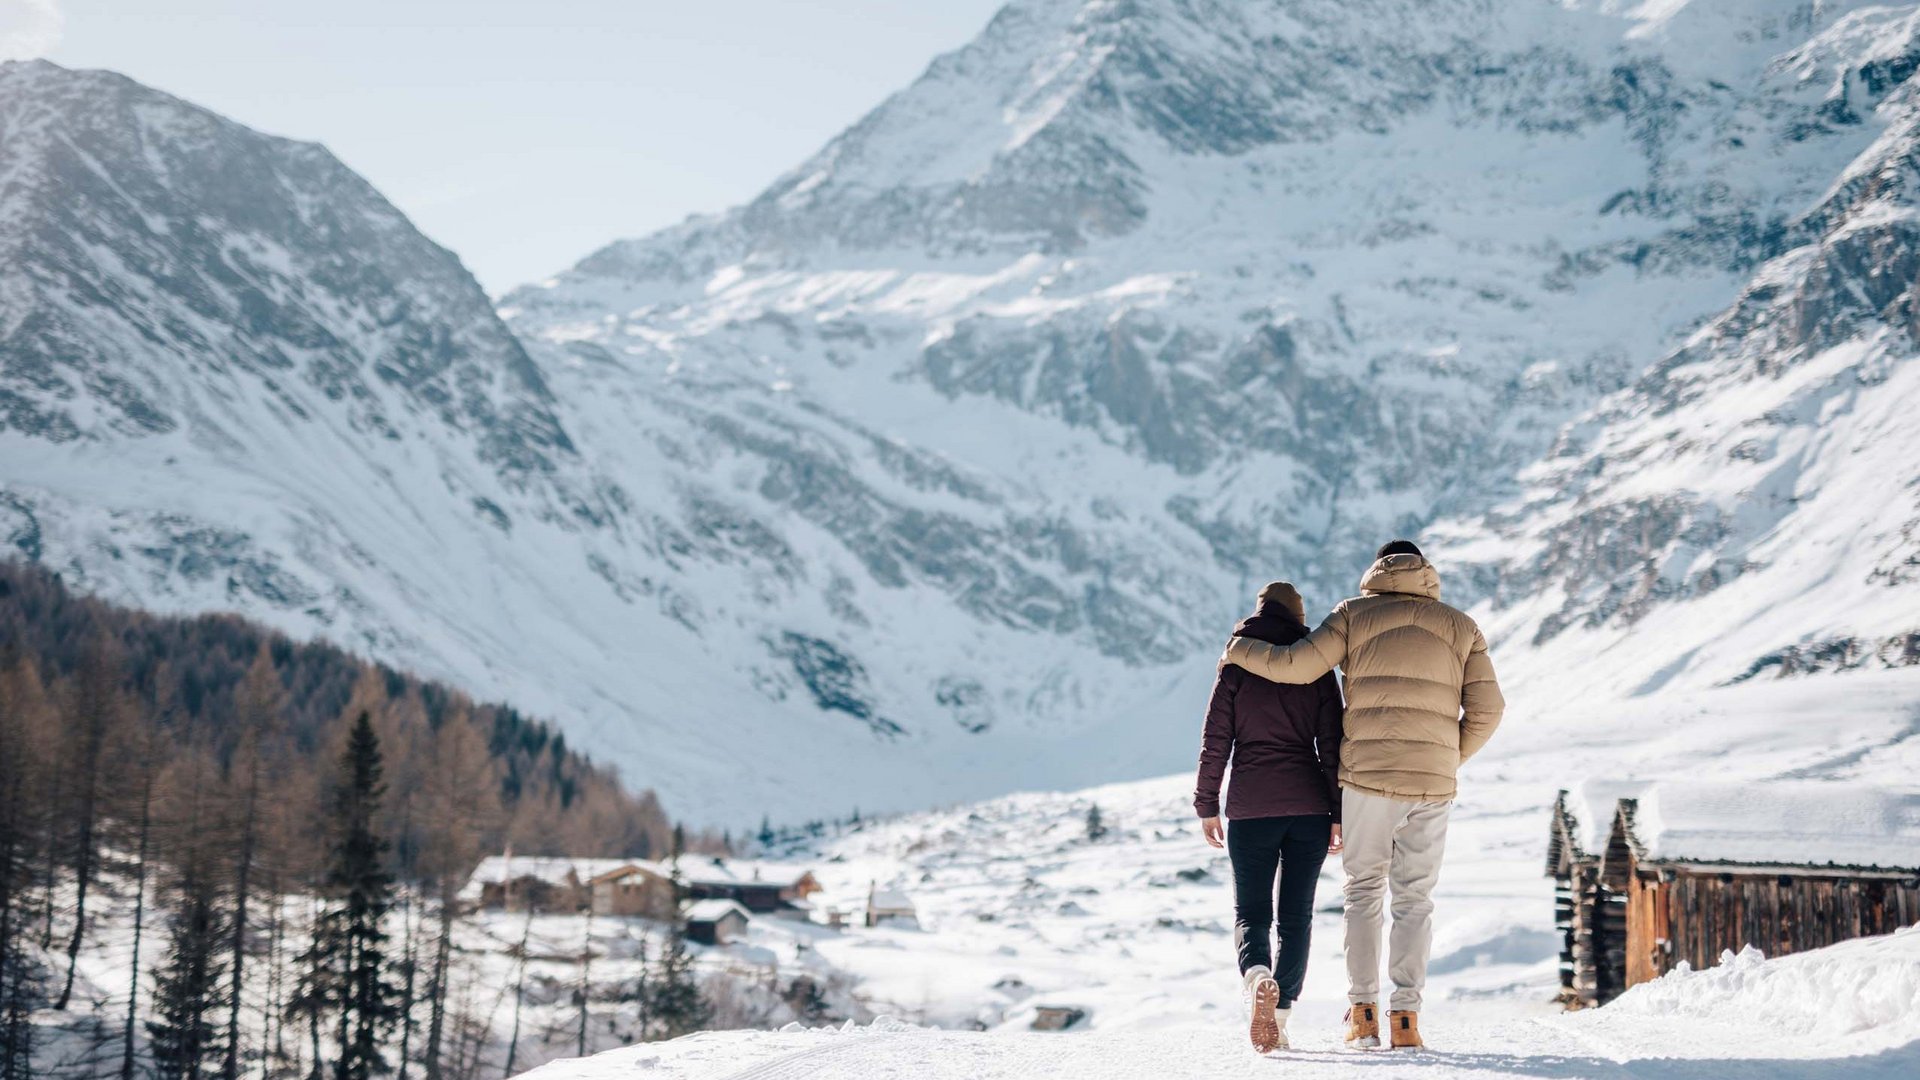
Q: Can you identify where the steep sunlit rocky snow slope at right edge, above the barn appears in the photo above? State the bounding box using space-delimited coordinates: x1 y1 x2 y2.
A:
1442 10 1920 686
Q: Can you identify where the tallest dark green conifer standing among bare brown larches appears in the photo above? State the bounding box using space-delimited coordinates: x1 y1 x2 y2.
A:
313 713 399 1080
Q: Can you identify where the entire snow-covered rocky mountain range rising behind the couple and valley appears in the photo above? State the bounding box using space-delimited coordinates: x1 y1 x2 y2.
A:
11 0 1920 821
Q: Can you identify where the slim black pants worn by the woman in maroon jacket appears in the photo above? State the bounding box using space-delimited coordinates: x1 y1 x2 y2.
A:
1227 813 1332 1009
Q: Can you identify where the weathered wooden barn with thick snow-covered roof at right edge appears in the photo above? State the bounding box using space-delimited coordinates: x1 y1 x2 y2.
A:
1548 782 1920 1007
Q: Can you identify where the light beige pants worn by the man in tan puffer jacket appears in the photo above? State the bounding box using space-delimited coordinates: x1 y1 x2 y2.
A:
1340 790 1453 1013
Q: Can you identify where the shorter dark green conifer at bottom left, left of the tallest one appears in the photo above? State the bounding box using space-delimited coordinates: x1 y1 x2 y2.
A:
146 880 225 1080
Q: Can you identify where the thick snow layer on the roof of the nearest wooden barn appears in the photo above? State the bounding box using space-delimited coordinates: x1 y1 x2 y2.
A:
1628 780 1920 871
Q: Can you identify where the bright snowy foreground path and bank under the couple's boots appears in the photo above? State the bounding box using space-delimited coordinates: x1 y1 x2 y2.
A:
526 928 1920 1080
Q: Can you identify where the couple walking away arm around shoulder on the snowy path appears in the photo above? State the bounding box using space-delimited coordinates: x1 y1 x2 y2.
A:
1194 540 1505 1053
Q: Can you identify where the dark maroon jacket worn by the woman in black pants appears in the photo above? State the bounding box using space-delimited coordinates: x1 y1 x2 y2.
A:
1194 603 1342 821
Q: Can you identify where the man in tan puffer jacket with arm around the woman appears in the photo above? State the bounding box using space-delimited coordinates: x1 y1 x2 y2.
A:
1219 540 1505 1047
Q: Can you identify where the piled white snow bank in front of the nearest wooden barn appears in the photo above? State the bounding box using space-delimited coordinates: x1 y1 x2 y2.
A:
1596 926 1920 1051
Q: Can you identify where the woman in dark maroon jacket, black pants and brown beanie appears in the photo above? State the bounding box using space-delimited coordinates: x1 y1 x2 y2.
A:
1194 580 1340 1053
